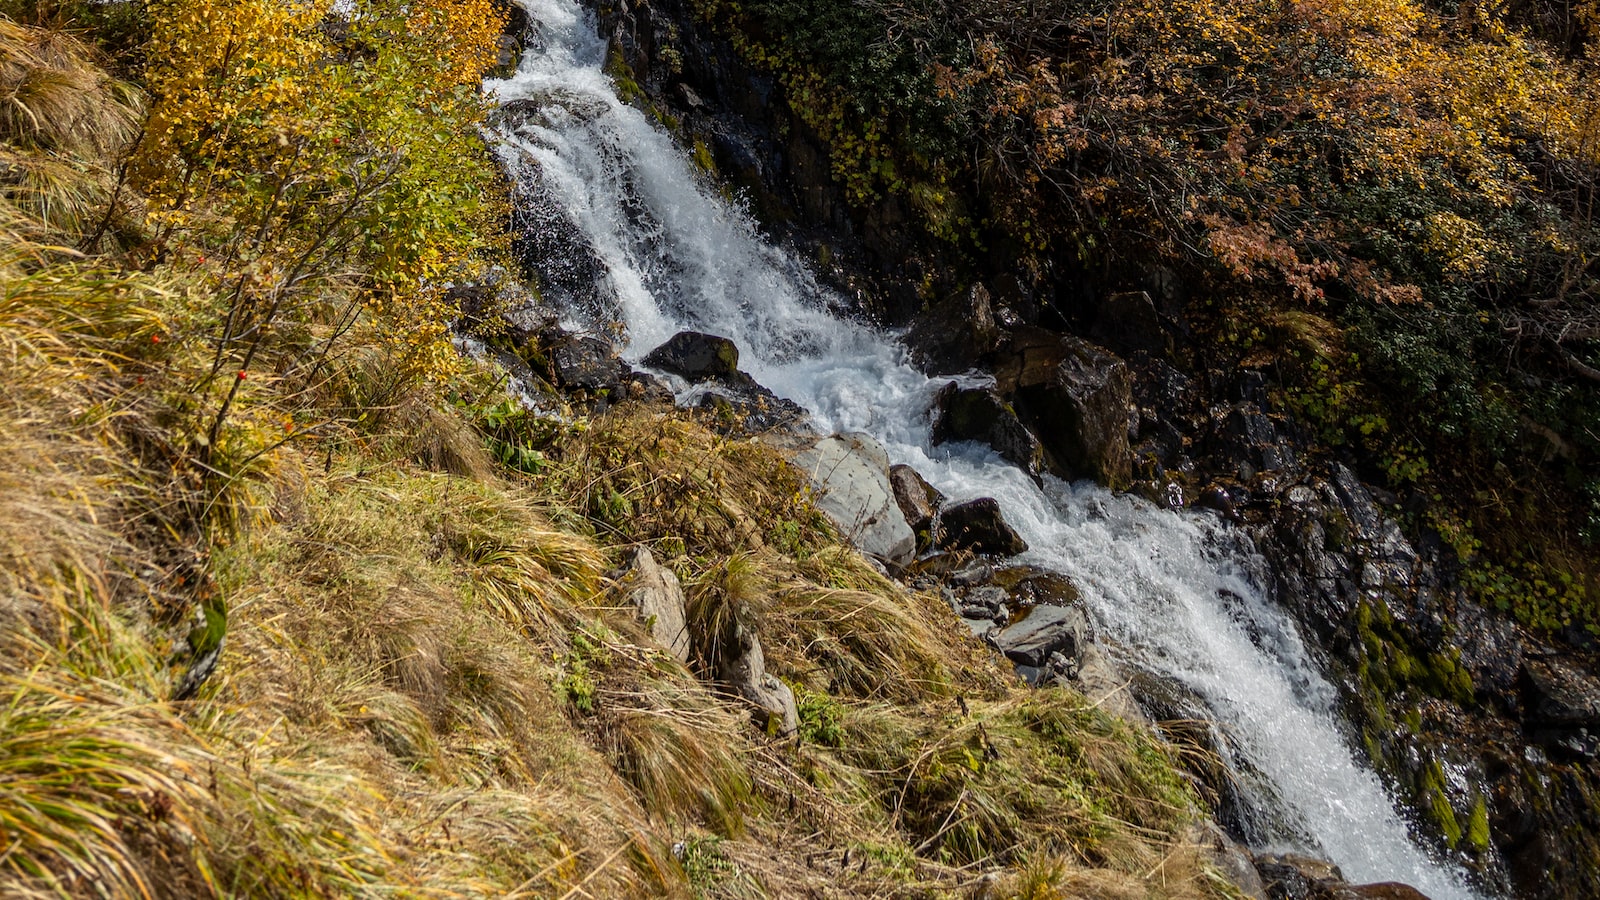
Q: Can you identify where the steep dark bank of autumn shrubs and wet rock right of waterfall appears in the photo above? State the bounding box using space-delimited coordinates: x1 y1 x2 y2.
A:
588 2 1600 895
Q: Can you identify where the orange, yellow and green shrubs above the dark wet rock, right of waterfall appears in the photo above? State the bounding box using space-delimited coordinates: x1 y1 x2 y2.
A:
693 0 1600 641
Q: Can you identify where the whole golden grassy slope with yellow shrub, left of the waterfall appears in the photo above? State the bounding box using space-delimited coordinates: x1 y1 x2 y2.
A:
0 0 1232 898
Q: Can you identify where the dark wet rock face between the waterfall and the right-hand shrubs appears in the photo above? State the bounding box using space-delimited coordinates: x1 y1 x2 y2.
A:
563 0 1600 897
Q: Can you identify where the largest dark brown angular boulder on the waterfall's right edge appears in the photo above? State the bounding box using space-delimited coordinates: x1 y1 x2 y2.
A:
1016 336 1138 490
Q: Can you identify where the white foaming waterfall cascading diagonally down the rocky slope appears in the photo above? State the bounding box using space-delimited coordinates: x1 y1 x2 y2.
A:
490 0 1475 900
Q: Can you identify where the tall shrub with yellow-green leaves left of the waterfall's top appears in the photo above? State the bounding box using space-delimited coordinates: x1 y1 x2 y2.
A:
134 0 502 460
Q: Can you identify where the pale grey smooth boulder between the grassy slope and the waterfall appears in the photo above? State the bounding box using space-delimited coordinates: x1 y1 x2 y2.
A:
770 434 917 565
